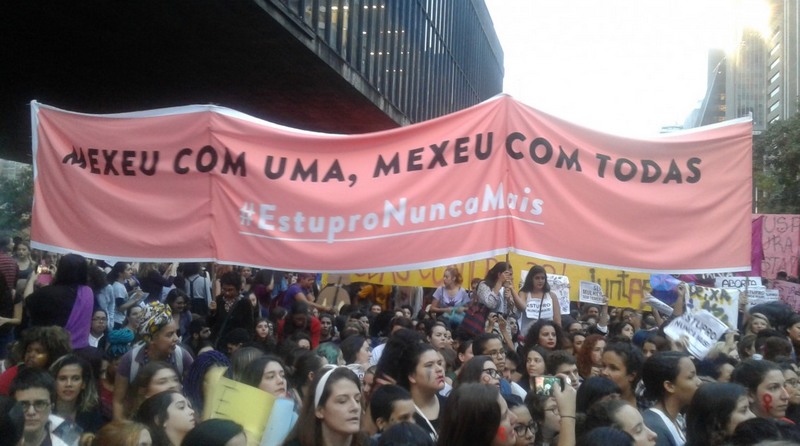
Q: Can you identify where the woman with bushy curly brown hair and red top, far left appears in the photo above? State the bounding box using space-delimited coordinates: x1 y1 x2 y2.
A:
0 326 72 395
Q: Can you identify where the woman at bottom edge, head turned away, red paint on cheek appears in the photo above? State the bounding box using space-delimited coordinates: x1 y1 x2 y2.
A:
437 383 517 446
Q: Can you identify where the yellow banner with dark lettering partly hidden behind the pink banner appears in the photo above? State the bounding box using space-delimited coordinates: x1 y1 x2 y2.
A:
332 254 650 308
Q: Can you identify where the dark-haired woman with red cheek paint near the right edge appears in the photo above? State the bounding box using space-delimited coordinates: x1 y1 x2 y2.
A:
731 359 789 420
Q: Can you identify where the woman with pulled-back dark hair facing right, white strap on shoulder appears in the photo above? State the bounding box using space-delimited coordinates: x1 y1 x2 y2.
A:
642 352 700 446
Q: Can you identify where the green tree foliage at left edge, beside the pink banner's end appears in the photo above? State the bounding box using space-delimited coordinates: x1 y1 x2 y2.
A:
0 166 33 233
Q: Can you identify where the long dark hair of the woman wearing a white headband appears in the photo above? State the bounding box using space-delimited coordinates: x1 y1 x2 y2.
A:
284 367 368 446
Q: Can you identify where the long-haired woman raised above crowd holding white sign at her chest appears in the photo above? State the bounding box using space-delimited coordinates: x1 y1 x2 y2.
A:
514 265 561 335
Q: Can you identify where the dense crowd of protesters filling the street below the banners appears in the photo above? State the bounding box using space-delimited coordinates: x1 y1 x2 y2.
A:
0 235 800 446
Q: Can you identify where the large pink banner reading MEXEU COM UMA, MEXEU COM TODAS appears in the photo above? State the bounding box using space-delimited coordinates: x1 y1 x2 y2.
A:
32 96 752 273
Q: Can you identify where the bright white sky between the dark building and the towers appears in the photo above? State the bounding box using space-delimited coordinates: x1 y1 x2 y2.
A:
485 0 768 136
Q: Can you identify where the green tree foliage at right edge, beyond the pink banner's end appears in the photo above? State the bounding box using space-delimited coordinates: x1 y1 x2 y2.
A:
753 114 800 214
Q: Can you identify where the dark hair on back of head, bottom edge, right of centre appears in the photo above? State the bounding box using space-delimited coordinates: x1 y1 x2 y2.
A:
438 383 502 446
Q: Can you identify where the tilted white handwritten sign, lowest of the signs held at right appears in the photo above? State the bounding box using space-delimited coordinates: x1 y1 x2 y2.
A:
664 310 728 359
